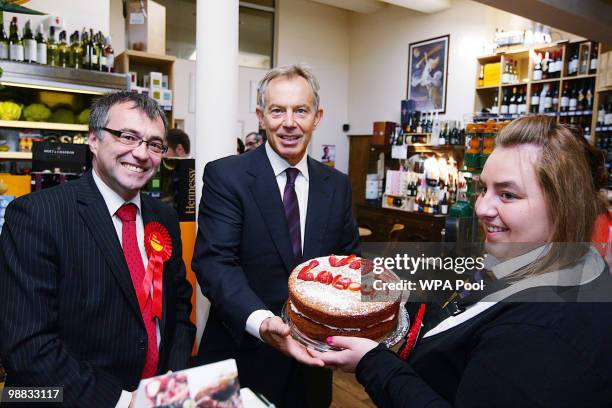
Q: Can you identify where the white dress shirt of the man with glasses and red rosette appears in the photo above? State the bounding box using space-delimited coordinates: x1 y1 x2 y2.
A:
91 170 161 408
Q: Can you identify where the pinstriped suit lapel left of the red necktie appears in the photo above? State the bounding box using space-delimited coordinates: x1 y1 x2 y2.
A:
78 172 141 316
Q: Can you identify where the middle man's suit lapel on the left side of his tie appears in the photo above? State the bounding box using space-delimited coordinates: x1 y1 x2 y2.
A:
247 147 295 271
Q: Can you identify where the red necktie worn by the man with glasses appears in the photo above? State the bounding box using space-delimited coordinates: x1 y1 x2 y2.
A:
117 203 159 378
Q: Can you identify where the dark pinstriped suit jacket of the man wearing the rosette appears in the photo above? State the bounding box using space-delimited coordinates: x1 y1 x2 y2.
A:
0 173 195 407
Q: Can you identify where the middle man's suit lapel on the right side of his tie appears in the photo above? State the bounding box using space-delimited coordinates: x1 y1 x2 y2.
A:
303 157 334 259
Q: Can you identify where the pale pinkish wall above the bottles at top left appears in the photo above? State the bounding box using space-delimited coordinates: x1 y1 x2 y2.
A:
4 0 110 38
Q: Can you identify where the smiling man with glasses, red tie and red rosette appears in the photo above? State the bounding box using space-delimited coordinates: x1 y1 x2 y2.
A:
0 92 195 407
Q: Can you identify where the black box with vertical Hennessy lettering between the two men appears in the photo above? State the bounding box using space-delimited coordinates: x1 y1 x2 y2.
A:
160 158 196 222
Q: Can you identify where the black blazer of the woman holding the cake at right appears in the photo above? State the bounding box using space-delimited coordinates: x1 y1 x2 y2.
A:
355 268 612 408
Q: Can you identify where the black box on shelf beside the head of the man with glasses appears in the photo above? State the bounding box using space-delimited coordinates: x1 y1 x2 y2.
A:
32 142 91 174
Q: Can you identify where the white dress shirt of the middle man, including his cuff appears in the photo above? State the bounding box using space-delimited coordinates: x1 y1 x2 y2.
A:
246 143 309 340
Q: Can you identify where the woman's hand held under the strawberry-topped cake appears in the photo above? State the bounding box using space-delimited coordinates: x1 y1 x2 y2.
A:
308 336 378 373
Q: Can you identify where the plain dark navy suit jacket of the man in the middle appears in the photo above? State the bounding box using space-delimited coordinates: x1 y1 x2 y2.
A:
193 145 359 402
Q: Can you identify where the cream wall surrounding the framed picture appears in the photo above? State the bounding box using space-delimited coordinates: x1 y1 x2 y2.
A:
348 0 579 134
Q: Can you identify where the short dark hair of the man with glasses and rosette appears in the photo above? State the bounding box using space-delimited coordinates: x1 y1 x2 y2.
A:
89 91 168 139
